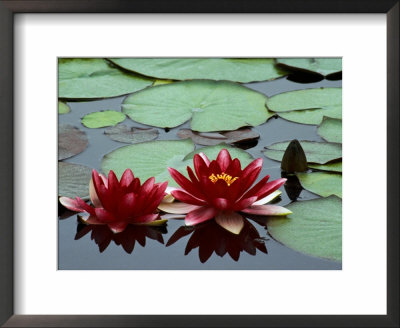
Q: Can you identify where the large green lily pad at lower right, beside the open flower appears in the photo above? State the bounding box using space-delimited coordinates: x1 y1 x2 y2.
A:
267 196 342 261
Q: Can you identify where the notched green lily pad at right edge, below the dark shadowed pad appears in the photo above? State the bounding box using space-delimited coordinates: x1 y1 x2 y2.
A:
266 88 342 125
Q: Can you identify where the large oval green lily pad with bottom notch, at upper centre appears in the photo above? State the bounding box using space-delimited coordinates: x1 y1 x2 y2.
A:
122 81 272 132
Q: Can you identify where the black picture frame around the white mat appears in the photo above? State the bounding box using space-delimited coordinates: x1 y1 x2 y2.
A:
0 0 400 327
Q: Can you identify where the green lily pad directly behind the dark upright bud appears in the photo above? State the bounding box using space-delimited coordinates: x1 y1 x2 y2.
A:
263 141 342 164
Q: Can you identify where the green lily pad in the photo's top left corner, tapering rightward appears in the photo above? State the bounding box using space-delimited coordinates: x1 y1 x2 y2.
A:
58 58 153 99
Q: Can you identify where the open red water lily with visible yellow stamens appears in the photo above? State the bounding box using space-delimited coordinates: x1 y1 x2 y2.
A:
159 149 291 234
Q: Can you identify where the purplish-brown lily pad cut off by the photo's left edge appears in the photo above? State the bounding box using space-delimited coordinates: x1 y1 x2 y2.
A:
58 124 88 160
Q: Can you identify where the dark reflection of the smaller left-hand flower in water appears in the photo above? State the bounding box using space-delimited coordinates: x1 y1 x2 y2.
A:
75 219 167 254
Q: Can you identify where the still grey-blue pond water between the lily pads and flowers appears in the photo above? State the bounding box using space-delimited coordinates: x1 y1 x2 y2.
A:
58 78 342 270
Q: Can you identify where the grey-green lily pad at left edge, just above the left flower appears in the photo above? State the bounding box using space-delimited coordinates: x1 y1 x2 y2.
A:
58 162 92 199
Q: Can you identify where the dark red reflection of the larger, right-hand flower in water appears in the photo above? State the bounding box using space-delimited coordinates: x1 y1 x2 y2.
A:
166 215 268 263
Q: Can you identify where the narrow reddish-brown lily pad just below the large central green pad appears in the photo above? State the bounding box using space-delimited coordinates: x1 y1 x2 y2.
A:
178 128 260 146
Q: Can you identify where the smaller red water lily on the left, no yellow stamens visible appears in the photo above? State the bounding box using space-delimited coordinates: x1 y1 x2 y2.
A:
60 169 168 233
